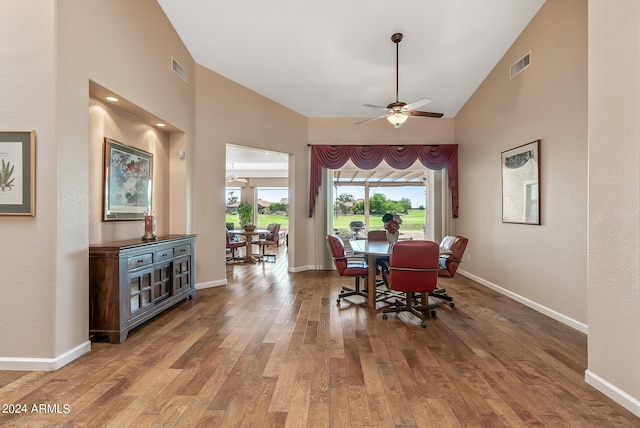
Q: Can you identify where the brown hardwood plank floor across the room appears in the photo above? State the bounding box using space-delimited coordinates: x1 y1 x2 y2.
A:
0 247 640 428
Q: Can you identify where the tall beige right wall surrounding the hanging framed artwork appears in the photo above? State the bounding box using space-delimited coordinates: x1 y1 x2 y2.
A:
455 0 587 332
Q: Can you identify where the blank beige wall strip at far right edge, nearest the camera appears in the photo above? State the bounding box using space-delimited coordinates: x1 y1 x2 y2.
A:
587 0 640 410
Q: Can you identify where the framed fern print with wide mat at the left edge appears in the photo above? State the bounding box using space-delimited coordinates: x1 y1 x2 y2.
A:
0 130 36 217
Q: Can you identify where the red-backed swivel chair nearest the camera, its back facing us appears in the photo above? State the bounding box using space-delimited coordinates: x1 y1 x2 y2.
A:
382 240 440 328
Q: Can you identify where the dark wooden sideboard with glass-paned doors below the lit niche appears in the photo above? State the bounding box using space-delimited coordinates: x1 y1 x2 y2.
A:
89 235 196 343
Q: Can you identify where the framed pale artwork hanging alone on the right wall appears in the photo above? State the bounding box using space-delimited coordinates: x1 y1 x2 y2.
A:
501 140 541 225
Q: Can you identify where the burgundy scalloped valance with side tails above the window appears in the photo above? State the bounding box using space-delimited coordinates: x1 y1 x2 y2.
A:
309 144 458 218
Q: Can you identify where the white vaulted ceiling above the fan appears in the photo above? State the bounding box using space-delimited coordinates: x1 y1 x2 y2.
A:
158 0 544 118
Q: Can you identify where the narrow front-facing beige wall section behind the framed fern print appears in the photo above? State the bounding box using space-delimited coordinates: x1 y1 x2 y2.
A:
0 0 57 362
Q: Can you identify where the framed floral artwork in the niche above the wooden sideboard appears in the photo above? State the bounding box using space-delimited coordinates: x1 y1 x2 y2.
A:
102 137 153 221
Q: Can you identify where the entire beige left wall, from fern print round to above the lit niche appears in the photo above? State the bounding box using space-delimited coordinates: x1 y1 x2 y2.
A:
0 0 195 369
